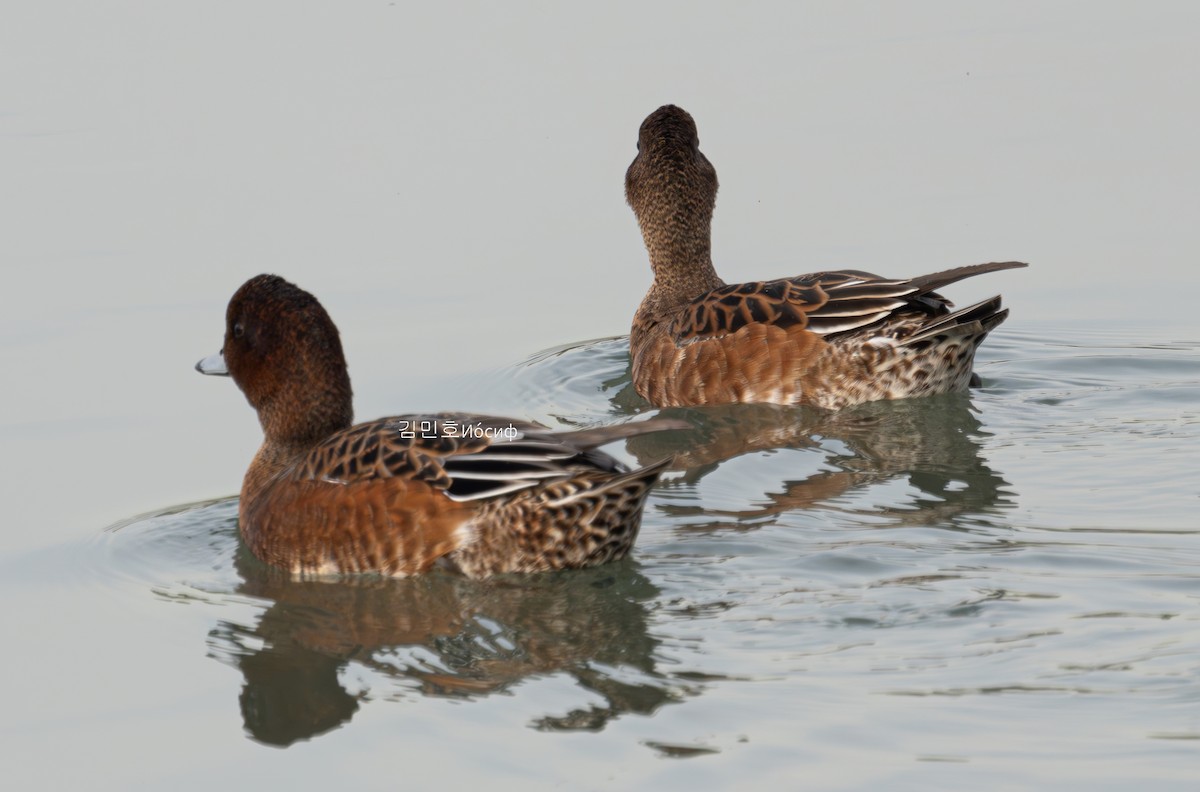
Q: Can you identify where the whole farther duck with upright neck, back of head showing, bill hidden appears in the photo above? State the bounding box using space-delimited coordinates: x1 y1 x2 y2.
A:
625 104 1026 409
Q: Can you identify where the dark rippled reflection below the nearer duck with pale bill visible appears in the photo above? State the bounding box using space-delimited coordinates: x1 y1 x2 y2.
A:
210 546 694 746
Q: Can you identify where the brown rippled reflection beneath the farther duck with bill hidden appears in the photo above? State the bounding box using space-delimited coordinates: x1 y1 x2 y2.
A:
614 394 1015 528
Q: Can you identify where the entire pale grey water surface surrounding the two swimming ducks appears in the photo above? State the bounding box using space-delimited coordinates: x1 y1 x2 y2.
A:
0 0 1200 792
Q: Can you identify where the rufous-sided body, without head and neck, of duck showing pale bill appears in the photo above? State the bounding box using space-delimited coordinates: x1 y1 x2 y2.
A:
239 413 666 577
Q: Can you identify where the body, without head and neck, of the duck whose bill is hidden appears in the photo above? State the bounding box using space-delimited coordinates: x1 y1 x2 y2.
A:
630 263 1014 409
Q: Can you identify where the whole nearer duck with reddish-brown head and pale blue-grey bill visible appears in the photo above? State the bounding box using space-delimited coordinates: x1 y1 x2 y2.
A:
196 275 686 577
